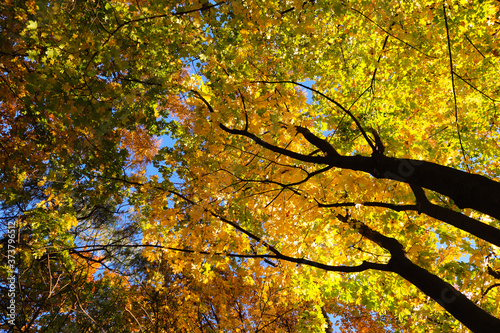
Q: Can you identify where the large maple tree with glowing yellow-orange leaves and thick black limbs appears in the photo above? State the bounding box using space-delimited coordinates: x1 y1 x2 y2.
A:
2 0 500 332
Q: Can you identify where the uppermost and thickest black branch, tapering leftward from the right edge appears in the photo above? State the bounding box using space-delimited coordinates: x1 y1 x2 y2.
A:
189 92 500 219
